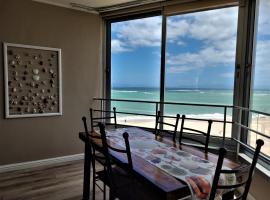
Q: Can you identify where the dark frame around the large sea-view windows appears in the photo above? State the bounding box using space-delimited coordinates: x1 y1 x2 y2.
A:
103 0 270 169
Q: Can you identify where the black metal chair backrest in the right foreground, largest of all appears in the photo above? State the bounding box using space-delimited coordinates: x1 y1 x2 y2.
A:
209 139 264 200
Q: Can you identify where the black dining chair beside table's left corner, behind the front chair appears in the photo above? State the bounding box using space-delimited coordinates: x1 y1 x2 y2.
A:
82 117 106 200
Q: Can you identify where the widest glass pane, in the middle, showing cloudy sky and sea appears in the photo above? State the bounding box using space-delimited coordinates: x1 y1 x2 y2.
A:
165 7 238 137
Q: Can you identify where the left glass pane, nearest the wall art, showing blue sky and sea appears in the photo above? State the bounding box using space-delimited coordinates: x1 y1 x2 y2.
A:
111 16 162 128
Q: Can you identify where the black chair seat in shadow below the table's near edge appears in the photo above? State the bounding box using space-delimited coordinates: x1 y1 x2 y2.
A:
97 166 165 200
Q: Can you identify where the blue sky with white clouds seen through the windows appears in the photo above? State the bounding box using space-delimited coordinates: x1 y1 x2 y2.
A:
111 3 270 89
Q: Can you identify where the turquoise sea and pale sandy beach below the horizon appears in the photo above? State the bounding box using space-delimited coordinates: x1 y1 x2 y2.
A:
111 88 270 155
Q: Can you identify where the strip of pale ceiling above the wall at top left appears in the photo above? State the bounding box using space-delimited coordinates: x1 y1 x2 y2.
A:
33 0 160 13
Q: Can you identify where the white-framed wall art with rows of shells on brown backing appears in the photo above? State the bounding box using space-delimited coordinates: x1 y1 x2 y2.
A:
3 43 62 118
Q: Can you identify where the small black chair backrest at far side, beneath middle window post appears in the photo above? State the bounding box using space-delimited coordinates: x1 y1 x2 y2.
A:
155 111 180 142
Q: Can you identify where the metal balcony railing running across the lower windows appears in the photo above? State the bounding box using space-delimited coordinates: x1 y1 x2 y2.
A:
93 98 270 160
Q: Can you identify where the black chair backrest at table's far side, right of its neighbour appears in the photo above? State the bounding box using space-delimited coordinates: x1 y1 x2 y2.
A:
179 115 213 153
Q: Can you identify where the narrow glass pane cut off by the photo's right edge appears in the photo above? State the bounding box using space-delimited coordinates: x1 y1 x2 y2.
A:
248 0 270 155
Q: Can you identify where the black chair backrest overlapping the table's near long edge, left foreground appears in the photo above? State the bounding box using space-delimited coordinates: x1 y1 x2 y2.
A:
98 123 133 175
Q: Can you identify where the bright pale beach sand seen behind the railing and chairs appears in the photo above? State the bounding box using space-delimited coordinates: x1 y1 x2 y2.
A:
117 116 270 155
